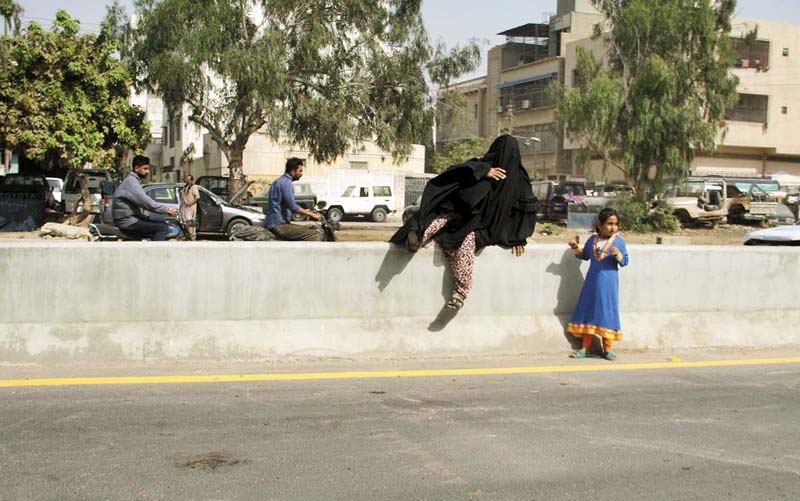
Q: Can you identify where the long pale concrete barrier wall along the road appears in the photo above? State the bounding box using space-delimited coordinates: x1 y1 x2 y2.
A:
0 242 800 363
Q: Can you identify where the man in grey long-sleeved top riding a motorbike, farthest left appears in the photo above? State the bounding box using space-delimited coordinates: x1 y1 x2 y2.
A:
111 155 175 241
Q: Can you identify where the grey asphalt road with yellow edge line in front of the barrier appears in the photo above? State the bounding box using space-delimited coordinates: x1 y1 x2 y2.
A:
0 354 800 500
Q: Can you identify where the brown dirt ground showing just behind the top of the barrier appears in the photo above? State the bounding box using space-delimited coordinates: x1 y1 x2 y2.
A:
0 225 758 245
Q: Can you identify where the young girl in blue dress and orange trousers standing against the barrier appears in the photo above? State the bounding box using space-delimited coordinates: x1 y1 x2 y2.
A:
567 208 628 360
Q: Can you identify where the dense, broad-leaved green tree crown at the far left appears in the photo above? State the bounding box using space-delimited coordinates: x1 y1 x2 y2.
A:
0 11 149 166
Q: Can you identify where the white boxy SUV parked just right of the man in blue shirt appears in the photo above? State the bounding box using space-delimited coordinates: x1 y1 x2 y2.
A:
324 185 395 223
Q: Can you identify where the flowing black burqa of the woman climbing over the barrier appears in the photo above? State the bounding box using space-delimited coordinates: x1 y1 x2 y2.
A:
391 135 536 249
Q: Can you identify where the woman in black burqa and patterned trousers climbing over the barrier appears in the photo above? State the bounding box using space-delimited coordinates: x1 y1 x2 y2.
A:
390 135 536 310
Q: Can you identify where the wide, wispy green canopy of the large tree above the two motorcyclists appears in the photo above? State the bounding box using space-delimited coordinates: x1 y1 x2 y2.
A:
130 0 480 189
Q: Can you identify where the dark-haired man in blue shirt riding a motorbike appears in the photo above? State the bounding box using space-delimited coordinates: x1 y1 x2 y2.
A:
264 158 322 241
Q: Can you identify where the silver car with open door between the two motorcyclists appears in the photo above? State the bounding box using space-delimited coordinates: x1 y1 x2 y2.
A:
143 183 266 237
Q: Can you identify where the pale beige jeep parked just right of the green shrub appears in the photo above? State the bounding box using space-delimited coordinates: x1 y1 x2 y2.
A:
665 177 728 227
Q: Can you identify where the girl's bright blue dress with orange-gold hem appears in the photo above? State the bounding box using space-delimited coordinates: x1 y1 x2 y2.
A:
567 234 628 341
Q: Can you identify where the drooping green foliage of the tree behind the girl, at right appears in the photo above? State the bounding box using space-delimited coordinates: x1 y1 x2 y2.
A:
550 0 738 192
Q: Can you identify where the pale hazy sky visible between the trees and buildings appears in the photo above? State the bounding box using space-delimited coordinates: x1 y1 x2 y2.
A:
17 0 800 78
